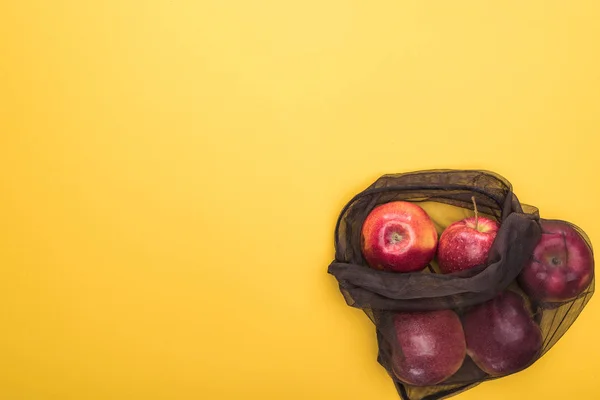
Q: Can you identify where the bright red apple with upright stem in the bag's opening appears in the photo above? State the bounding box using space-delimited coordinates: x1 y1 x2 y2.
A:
437 197 500 274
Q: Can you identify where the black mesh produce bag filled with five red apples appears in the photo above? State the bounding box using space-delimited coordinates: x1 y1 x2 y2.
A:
328 170 594 400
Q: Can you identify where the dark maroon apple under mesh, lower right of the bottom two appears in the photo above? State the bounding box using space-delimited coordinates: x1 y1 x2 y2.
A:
463 291 542 376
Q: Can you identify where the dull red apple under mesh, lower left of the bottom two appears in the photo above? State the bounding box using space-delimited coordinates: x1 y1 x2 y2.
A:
392 310 466 386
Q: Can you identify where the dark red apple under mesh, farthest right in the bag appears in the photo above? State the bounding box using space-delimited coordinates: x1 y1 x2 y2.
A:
519 220 594 302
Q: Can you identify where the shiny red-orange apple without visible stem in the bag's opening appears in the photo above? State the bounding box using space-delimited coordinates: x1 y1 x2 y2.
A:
361 201 438 272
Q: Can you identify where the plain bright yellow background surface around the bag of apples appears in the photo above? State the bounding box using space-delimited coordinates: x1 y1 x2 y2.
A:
0 0 600 400
